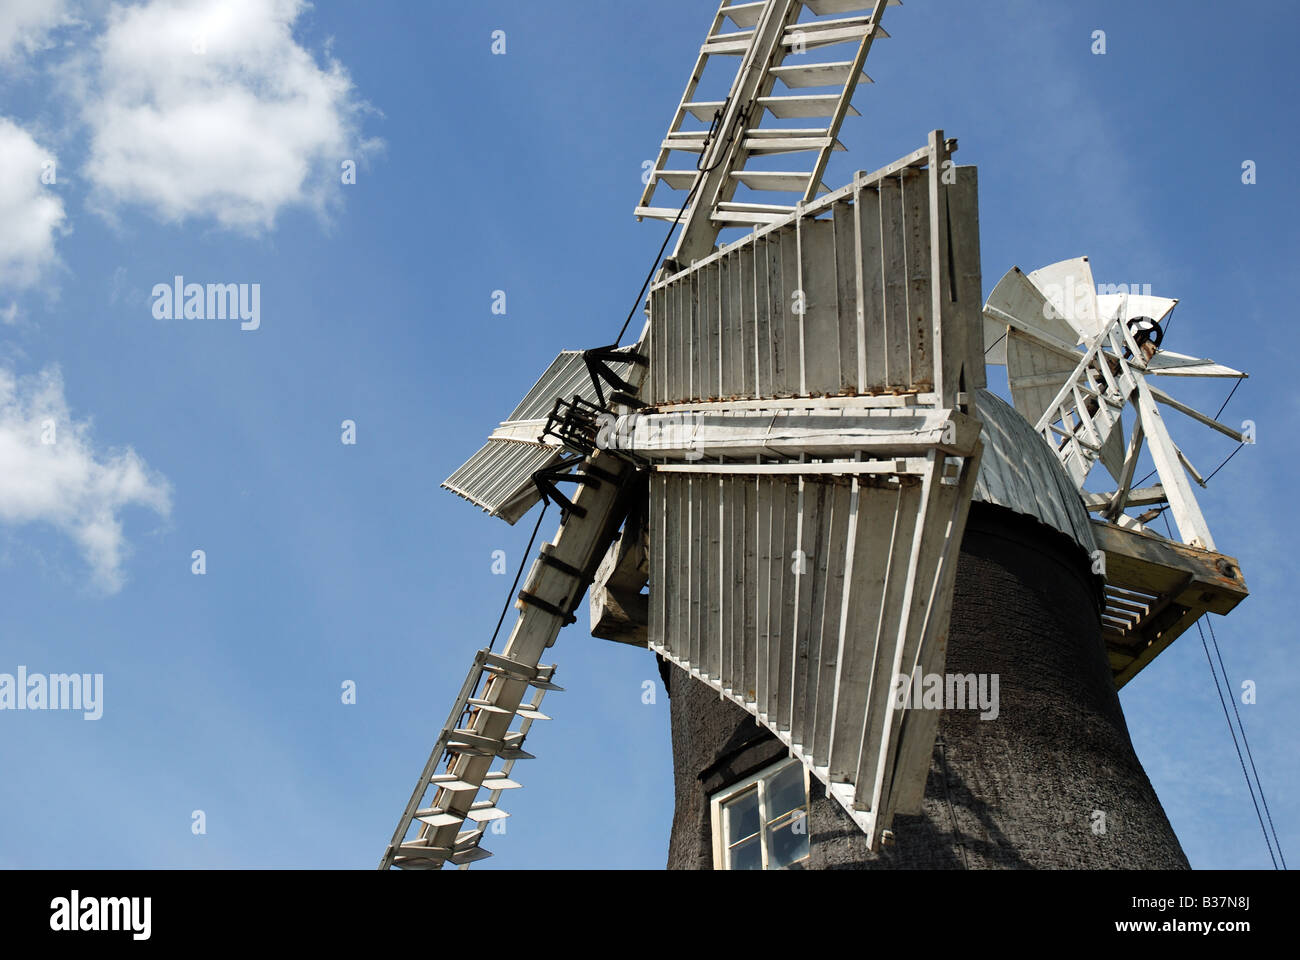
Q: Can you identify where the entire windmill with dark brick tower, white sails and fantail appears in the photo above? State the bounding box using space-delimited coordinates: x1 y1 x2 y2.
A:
381 0 1247 869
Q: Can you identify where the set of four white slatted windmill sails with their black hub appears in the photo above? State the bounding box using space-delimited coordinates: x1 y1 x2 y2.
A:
381 0 983 869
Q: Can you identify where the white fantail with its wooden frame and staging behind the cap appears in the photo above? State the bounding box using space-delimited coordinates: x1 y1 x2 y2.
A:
984 256 1247 686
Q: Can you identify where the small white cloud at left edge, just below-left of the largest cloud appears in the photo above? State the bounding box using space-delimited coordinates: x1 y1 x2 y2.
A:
0 117 64 287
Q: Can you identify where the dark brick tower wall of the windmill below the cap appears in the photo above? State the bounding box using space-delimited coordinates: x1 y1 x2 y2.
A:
660 503 1188 869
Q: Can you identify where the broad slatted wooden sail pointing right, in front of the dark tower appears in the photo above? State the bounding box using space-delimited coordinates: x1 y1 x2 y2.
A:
619 131 983 846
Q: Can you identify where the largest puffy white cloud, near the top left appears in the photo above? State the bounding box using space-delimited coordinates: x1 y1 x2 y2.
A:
85 0 373 230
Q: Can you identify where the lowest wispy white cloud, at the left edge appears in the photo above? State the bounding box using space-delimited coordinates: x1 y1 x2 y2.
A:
0 368 172 593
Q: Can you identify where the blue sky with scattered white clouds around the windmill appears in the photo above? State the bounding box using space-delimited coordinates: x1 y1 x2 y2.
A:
0 0 1300 869
